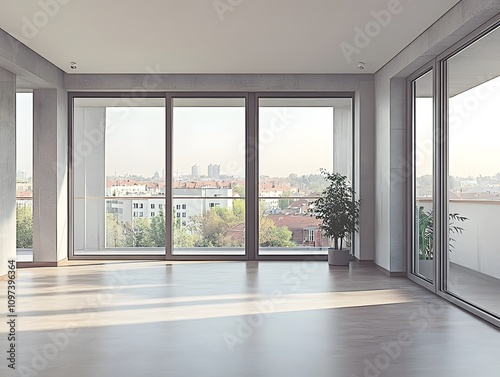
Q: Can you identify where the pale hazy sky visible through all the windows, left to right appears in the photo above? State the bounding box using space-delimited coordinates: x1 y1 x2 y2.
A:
17 82 500 181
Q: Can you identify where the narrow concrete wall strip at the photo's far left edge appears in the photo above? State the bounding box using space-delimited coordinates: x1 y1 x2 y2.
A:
0 68 16 276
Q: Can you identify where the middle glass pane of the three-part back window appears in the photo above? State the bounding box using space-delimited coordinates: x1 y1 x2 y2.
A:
172 98 245 255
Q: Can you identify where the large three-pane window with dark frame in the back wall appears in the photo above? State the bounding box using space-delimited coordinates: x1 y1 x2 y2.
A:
71 93 353 259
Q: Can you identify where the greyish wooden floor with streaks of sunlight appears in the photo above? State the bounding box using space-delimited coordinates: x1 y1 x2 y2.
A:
0 261 500 377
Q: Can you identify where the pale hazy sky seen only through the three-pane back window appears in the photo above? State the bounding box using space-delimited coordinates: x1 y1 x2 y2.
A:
106 103 333 177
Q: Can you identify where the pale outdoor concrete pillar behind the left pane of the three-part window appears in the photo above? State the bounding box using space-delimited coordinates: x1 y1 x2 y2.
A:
73 105 106 252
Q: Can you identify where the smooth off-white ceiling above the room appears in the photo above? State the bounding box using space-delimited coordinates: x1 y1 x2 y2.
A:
0 0 459 73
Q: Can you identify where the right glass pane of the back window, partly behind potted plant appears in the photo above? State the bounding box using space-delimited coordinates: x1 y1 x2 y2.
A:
259 98 352 255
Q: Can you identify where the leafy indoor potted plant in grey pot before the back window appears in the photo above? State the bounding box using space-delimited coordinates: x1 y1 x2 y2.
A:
310 169 360 266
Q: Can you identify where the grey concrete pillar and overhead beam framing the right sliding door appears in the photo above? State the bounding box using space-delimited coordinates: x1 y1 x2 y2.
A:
375 0 500 272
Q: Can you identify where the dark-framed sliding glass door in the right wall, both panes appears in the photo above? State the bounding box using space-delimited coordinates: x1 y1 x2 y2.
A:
408 19 500 324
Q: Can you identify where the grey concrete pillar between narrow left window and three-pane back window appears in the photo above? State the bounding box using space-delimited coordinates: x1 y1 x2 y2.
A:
33 89 68 265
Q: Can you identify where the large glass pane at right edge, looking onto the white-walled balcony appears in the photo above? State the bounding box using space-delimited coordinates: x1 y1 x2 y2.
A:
446 25 500 316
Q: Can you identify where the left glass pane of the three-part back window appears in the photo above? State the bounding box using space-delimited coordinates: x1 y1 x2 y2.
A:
73 98 165 255
